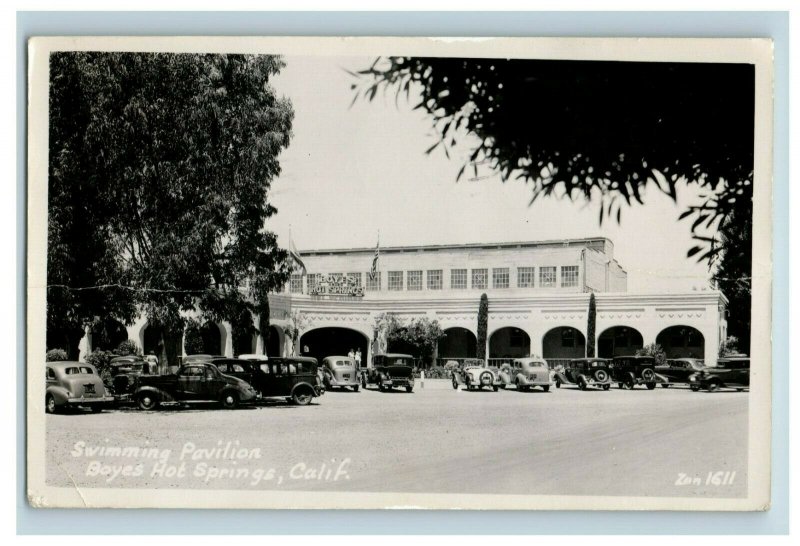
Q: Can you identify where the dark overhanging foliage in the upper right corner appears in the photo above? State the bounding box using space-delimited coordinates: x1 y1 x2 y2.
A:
353 57 755 262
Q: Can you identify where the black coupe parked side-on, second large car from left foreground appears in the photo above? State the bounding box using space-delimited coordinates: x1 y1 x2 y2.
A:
134 362 259 410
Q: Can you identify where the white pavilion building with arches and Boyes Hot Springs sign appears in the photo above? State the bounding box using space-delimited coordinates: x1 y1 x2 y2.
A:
79 238 727 364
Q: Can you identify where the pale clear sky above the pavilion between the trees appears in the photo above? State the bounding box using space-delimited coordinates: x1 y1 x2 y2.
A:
267 55 709 293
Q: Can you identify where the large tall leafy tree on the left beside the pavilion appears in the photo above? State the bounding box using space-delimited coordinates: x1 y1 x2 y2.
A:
48 52 293 362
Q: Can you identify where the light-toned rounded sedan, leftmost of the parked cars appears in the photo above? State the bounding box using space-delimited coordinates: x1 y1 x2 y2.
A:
44 362 114 413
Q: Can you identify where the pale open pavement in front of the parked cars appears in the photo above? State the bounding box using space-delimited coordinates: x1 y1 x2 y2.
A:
47 379 748 497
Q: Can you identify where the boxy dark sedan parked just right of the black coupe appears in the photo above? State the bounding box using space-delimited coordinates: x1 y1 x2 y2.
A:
212 357 325 406
